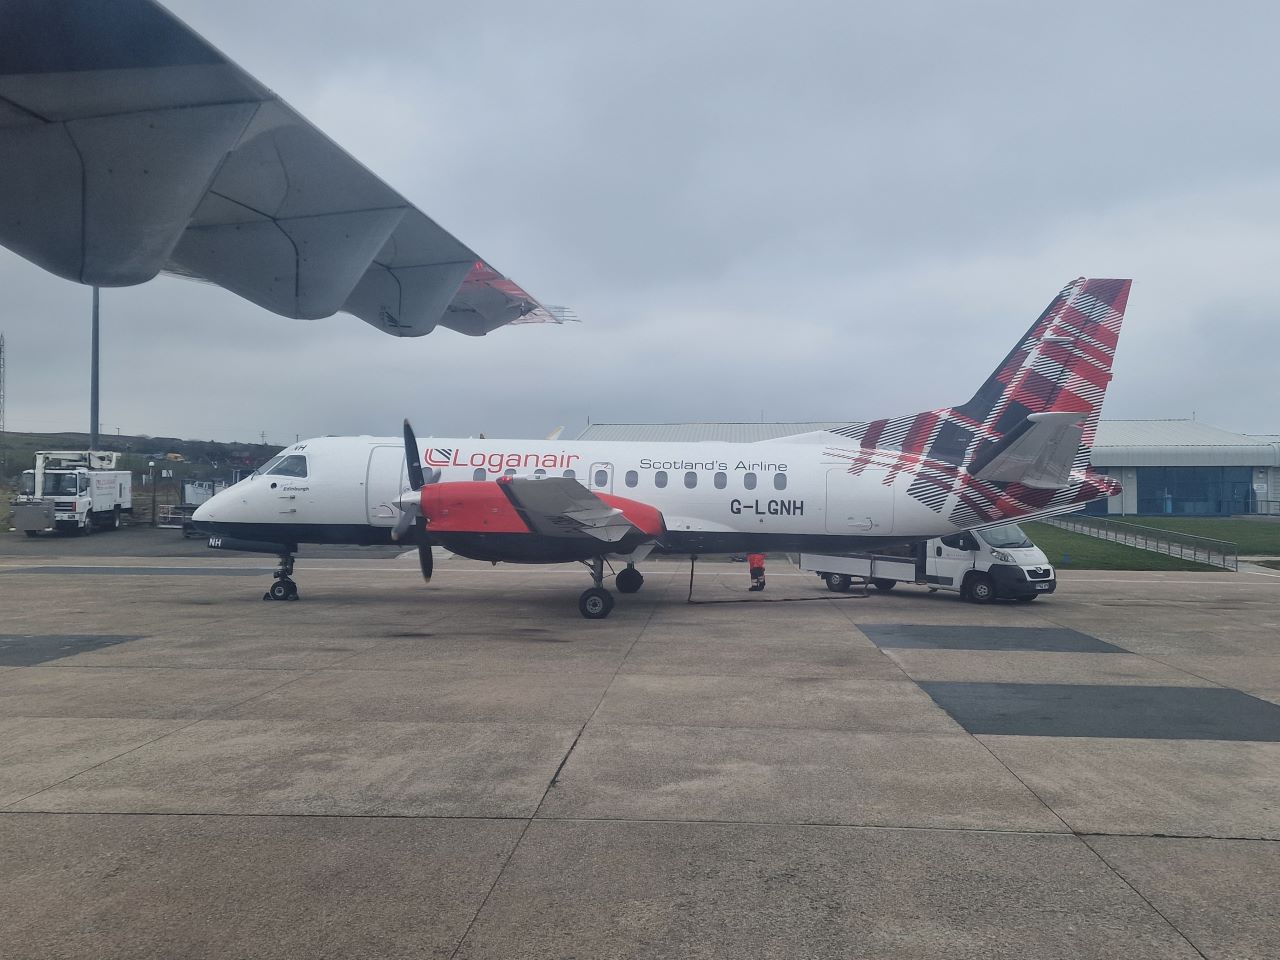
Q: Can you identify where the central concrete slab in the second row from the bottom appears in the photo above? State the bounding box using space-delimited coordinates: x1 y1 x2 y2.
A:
539 723 1066 832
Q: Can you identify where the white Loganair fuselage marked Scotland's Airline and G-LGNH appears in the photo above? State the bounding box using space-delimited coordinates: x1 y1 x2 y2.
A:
195 436 977 553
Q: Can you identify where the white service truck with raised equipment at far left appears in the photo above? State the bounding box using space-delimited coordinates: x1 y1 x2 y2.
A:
12 451 133 536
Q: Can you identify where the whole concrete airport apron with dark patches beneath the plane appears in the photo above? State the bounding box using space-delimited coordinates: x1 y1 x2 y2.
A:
0 530 1280 960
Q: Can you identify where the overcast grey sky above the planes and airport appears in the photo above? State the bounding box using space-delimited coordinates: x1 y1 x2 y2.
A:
0 0 1280 443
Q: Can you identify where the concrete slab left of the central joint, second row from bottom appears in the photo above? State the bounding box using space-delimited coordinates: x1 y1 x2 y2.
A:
14 719 577 817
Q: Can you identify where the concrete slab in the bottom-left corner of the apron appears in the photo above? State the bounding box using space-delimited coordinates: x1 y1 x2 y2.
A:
0 814 524 960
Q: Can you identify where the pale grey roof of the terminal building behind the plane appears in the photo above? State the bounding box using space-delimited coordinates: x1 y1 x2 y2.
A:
577 420 1280 467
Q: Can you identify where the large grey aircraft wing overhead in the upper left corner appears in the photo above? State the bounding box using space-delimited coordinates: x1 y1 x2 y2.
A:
0 0 573 337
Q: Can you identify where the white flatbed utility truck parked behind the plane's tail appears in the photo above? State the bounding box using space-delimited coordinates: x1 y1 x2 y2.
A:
800 524 1057 603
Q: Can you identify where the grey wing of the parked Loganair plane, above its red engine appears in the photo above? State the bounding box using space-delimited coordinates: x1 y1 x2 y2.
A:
498 476 662 543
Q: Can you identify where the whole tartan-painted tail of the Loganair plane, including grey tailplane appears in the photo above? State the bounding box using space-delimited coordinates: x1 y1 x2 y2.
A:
831 276 1132 526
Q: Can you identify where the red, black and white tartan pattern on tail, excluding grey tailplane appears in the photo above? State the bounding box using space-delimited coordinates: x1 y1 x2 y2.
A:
826 276 1132 526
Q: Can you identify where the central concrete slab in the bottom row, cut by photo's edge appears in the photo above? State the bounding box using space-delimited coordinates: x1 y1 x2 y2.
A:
458 820 1198 960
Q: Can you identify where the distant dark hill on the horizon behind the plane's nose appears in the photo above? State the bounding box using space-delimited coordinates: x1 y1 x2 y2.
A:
0 433 280 484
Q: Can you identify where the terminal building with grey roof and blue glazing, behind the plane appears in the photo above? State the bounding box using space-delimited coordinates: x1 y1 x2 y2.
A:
579 420 1280 516
